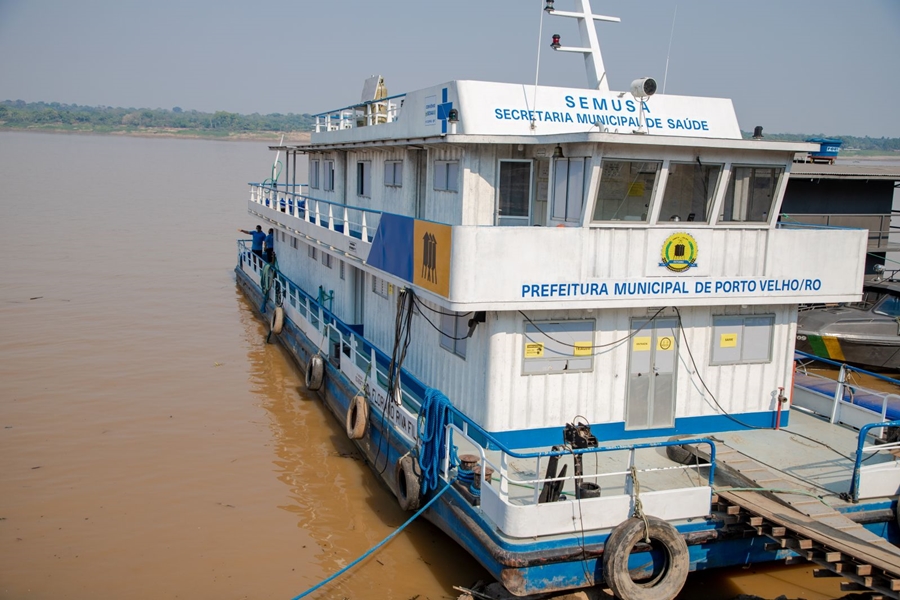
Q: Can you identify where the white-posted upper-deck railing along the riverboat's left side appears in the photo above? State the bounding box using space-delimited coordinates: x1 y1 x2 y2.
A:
250 183 382 243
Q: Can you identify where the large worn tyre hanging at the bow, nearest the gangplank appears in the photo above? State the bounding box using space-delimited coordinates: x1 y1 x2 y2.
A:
603 517 690 600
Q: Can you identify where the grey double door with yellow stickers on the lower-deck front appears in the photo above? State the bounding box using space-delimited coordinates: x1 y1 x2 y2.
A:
625 319 678 429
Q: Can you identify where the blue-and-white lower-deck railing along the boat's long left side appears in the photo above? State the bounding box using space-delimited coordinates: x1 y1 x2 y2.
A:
238 240 425 415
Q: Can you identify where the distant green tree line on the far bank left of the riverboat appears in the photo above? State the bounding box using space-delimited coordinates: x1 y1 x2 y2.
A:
0 100 315 133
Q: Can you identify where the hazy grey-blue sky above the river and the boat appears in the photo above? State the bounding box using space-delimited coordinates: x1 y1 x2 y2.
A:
0 0 900 137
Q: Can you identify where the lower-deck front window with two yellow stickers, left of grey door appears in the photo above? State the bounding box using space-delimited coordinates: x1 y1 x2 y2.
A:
522 319 594 375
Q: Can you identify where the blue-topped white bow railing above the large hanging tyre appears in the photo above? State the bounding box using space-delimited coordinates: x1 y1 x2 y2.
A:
443 418 716 505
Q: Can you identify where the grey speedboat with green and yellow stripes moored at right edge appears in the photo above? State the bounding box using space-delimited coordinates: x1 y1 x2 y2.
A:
797 279 900 372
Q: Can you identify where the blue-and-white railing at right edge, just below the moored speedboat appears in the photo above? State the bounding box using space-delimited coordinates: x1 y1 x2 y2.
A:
793 350 900 434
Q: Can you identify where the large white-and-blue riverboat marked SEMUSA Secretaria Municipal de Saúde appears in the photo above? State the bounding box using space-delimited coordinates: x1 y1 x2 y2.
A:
235 0 900 600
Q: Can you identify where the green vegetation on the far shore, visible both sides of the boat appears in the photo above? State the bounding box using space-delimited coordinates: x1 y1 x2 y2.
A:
0 100 900 156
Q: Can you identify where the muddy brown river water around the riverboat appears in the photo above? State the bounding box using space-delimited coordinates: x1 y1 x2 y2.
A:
0 132 841 600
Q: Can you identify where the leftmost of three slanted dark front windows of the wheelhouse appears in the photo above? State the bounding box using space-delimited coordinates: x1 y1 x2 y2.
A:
593 160 662 223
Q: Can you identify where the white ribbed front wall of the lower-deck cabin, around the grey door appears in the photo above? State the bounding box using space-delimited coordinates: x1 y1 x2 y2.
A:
486 305 796 431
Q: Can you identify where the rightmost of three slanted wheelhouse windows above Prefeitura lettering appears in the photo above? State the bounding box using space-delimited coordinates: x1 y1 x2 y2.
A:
719 166 784 223
